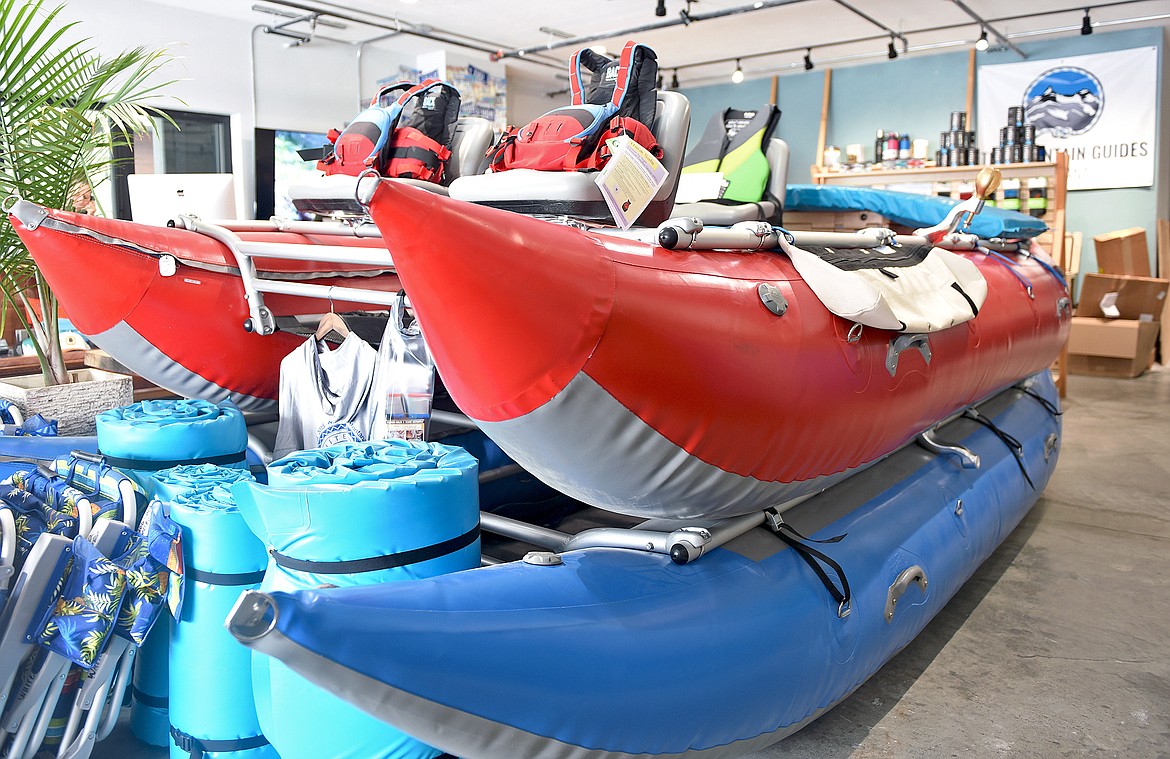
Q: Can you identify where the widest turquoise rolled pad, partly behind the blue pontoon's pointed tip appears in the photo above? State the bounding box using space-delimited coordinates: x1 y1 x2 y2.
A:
232 440 480 759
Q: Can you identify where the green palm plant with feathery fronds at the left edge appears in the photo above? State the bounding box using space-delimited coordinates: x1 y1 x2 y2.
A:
0 0 170 384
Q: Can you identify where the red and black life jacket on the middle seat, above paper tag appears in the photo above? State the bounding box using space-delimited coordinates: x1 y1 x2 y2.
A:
488 42 662 171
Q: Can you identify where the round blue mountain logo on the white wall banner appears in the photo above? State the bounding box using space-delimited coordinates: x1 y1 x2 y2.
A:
1024 65 1104 138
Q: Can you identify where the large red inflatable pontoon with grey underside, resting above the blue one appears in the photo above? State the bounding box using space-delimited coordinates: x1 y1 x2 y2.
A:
370 181 1069 518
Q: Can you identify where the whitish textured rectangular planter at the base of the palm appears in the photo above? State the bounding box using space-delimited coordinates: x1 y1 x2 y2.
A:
0 368 135 435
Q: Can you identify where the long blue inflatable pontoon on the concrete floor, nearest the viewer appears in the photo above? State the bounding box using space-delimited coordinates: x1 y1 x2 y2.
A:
228 372 1060 759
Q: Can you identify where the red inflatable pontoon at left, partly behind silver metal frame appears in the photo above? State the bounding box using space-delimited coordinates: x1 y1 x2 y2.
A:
11 201 400 410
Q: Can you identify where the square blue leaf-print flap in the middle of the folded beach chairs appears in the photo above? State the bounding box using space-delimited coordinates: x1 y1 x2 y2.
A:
29 537 126 669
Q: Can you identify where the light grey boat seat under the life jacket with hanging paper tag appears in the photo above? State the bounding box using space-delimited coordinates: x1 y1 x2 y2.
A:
450 90 690 227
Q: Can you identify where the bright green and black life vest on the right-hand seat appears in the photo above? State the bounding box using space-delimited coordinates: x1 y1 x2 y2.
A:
682 104 780 202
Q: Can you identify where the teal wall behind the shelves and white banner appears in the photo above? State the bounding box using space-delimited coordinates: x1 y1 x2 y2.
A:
682 27 1170 280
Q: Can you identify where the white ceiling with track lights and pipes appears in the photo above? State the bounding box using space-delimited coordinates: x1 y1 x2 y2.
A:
154 0 1170 87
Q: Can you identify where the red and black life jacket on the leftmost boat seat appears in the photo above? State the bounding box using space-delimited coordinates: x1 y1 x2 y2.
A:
317 80 460 182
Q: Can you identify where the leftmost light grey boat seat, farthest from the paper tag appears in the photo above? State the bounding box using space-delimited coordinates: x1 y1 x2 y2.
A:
289 116 495 216
